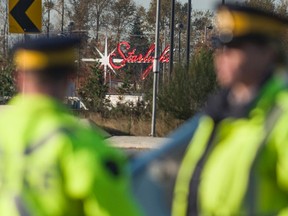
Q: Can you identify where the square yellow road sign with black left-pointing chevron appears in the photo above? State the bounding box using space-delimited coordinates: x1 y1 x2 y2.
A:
9 0 42 33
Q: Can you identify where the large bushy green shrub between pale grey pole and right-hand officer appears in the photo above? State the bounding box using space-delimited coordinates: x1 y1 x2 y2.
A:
158 46 217 120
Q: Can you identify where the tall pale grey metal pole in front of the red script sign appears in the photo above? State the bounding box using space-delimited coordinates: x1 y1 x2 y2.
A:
151 0 161 137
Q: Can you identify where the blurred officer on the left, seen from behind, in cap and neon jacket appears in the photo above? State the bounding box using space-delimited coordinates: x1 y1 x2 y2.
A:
0 37 140 216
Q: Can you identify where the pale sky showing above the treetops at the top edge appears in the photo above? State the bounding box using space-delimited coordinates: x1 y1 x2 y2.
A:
135 0 241 10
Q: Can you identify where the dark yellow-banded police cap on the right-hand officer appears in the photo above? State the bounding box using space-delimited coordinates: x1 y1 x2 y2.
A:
216 4 288 44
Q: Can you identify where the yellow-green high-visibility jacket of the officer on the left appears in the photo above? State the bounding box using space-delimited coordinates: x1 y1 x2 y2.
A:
0 95 140 216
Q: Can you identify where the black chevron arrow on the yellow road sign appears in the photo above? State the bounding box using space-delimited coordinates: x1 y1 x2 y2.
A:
10 0 40 32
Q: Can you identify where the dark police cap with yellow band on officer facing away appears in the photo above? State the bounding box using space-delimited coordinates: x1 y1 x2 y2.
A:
13 37 80 71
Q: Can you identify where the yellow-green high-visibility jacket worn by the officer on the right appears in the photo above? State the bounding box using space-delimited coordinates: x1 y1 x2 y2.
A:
172 73 288 216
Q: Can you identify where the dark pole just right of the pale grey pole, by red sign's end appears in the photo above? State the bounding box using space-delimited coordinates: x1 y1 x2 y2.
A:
168 0 175 80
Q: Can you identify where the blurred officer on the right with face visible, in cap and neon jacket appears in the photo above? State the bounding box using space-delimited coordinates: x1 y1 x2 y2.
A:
172 4 288 216
